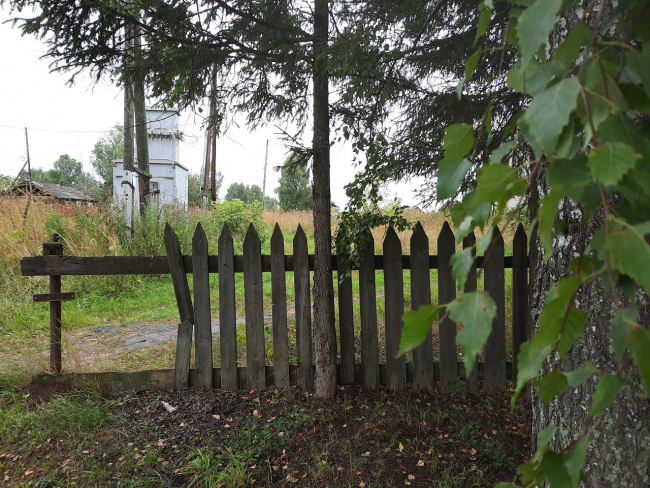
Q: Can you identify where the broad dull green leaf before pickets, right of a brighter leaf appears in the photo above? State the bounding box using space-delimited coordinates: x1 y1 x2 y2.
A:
447 291 497 377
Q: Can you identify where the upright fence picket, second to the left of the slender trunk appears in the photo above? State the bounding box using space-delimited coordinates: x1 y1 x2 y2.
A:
271 223 289 388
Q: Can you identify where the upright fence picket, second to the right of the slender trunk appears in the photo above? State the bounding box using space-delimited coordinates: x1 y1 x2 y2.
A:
359 231 379 388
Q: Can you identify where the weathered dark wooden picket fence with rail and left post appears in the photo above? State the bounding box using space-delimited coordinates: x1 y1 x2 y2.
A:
21 223 528 391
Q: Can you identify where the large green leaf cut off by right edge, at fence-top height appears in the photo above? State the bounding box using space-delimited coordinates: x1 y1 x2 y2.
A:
605 221 650 293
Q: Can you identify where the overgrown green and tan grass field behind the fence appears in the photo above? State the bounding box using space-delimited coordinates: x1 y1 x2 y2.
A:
0 201 512 385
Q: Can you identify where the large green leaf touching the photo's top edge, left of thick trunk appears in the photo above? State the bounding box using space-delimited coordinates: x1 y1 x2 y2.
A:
517 0 562 68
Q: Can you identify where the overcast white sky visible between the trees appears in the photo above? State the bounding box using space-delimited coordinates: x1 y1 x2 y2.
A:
0 9 416 206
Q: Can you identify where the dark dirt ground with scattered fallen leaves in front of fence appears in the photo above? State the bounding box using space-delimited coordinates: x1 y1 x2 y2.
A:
0 385 530 488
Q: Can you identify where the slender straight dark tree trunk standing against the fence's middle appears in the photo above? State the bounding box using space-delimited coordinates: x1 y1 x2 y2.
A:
313 0 336 398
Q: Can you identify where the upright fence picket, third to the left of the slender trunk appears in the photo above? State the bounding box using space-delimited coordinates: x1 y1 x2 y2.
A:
244 223 266 389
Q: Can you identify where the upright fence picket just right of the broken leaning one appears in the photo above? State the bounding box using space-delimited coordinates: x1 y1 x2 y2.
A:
192 222 212 388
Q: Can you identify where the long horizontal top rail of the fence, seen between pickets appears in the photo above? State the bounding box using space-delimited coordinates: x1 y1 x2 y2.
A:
20 254 512 276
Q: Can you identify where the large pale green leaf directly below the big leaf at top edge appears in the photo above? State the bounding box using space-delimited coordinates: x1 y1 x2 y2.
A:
521 77 580 154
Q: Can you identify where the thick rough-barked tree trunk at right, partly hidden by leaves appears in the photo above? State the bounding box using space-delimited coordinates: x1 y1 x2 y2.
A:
530 2 650 488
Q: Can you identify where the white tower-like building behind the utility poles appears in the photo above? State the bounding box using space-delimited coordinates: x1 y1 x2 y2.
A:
113 108 189 208
